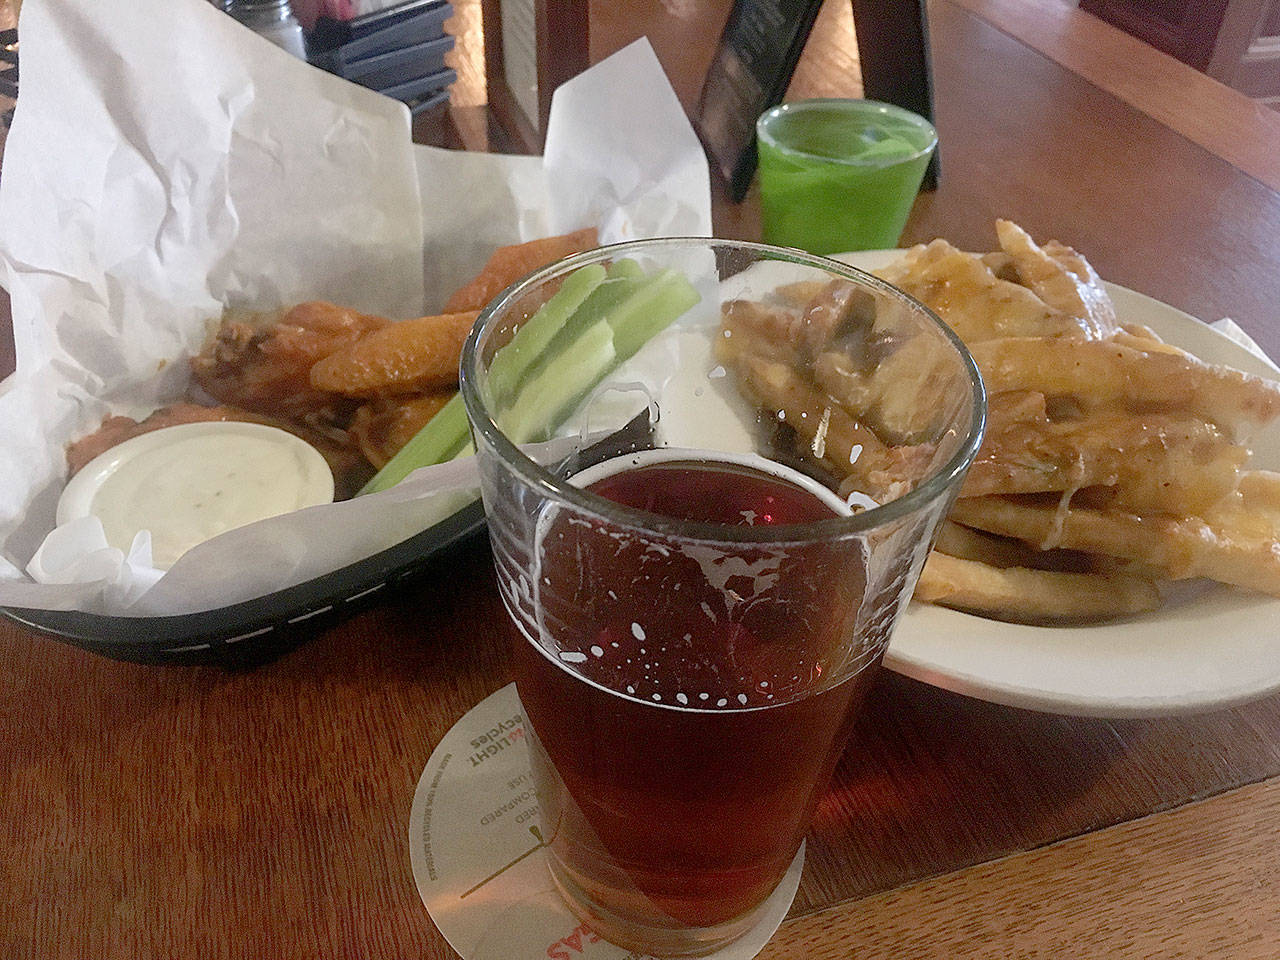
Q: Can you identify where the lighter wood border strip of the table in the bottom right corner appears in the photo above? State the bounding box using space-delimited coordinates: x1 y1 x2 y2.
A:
760 781 1280 960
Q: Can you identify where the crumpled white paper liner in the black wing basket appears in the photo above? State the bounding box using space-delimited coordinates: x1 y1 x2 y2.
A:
0 0 710 616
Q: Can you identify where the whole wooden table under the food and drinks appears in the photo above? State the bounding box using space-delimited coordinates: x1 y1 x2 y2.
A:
0 0 1280 960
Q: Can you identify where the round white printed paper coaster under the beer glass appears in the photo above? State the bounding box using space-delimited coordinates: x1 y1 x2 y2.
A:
408 684 804 960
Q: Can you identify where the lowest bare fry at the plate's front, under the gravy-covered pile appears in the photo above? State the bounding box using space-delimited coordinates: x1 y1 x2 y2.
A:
915 550 1160 623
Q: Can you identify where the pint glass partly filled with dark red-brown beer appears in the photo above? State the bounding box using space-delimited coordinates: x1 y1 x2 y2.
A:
462 238 986 956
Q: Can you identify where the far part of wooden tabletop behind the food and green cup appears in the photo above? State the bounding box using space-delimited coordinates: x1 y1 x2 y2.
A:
583 0 1280 356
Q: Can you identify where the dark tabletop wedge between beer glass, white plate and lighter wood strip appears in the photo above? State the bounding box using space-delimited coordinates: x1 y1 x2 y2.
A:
792 671 1276 914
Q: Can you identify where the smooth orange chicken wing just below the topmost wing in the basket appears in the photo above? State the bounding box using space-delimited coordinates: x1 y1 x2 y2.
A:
311 311 477 397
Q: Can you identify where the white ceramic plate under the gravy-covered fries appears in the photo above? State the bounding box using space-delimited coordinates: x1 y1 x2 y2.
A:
840 251 1280 717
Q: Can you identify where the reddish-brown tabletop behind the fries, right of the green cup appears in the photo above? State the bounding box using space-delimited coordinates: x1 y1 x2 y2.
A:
902 0 1280 356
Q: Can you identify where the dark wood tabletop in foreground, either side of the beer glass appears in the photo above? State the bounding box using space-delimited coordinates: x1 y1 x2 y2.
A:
0 556 1280 957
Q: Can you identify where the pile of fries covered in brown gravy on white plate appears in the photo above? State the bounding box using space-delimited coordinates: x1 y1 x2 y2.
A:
716 221 1280 623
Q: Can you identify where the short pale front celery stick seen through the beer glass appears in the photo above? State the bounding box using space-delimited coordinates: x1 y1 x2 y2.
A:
502 320 617 443
